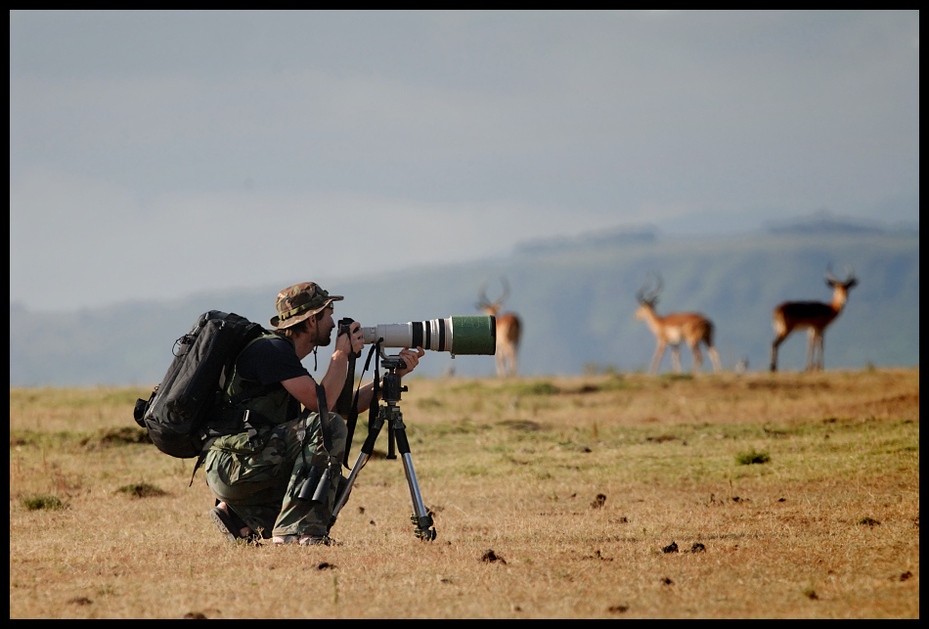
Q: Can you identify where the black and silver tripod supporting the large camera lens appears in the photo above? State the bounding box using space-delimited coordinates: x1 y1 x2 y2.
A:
332 356 435 541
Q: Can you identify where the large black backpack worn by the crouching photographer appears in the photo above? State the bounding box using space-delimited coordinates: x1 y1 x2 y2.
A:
133 310 268 459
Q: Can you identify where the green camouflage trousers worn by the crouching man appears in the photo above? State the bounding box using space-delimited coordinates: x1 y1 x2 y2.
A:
204 413 348 539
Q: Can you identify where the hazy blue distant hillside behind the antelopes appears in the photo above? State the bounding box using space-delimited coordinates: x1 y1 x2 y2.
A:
10 219 919 386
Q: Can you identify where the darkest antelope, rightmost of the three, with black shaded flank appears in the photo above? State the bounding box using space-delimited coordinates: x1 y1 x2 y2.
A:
771 267 858 371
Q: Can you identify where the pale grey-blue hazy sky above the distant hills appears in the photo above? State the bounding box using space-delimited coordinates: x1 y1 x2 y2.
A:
10 11 919 310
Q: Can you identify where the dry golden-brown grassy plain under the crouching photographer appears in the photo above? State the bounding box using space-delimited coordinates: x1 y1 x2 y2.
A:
10 368 919 619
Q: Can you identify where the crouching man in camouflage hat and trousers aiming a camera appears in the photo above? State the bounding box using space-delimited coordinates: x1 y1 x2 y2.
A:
204 282 425 545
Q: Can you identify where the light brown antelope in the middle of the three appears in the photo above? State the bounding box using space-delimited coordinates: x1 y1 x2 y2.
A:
635 276 722 374
